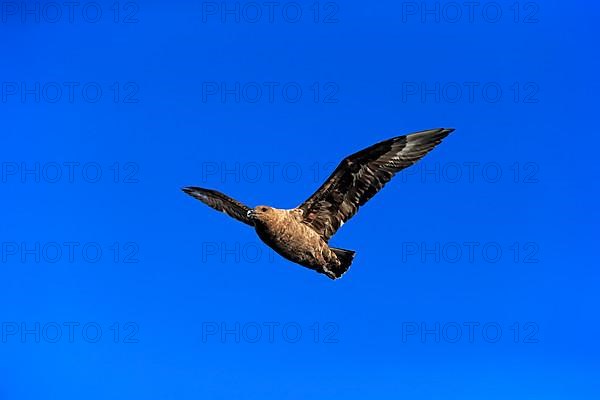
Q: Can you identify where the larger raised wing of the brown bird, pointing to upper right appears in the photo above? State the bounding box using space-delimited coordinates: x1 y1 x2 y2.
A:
297 128 454 241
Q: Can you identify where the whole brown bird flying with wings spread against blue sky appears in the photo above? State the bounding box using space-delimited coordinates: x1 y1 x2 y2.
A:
182 128 454 279
